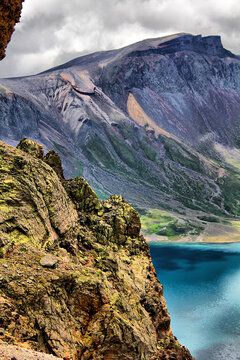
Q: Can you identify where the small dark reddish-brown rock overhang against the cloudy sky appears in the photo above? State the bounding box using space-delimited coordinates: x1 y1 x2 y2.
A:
0 0 24 60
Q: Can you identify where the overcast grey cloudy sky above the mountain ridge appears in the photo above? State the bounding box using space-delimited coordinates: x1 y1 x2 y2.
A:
0 0 240 77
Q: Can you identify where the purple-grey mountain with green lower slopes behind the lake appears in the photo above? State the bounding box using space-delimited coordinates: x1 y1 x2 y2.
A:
0 33 240 216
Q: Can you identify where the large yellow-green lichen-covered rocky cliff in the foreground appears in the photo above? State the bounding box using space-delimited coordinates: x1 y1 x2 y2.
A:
0 140 192 360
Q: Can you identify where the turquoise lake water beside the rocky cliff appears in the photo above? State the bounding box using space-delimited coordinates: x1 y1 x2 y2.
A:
150 242 240 360
